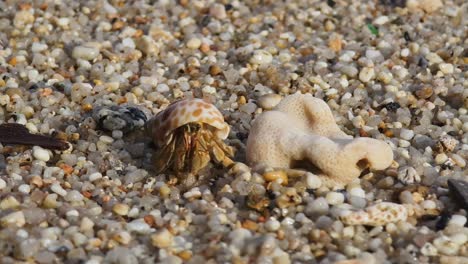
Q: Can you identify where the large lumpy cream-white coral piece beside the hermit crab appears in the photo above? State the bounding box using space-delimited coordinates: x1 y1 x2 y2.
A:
246 94 393 188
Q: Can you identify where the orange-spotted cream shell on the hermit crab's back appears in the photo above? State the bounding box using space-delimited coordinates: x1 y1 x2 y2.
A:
146 99 229 146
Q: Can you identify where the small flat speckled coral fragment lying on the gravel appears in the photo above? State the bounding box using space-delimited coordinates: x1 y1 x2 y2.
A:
340 202 408 226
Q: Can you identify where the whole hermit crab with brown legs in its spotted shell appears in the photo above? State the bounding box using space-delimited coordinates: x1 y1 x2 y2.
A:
145 99 234 185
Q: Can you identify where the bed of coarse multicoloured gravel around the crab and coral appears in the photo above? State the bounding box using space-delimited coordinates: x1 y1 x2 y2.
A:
0 0 468 264
